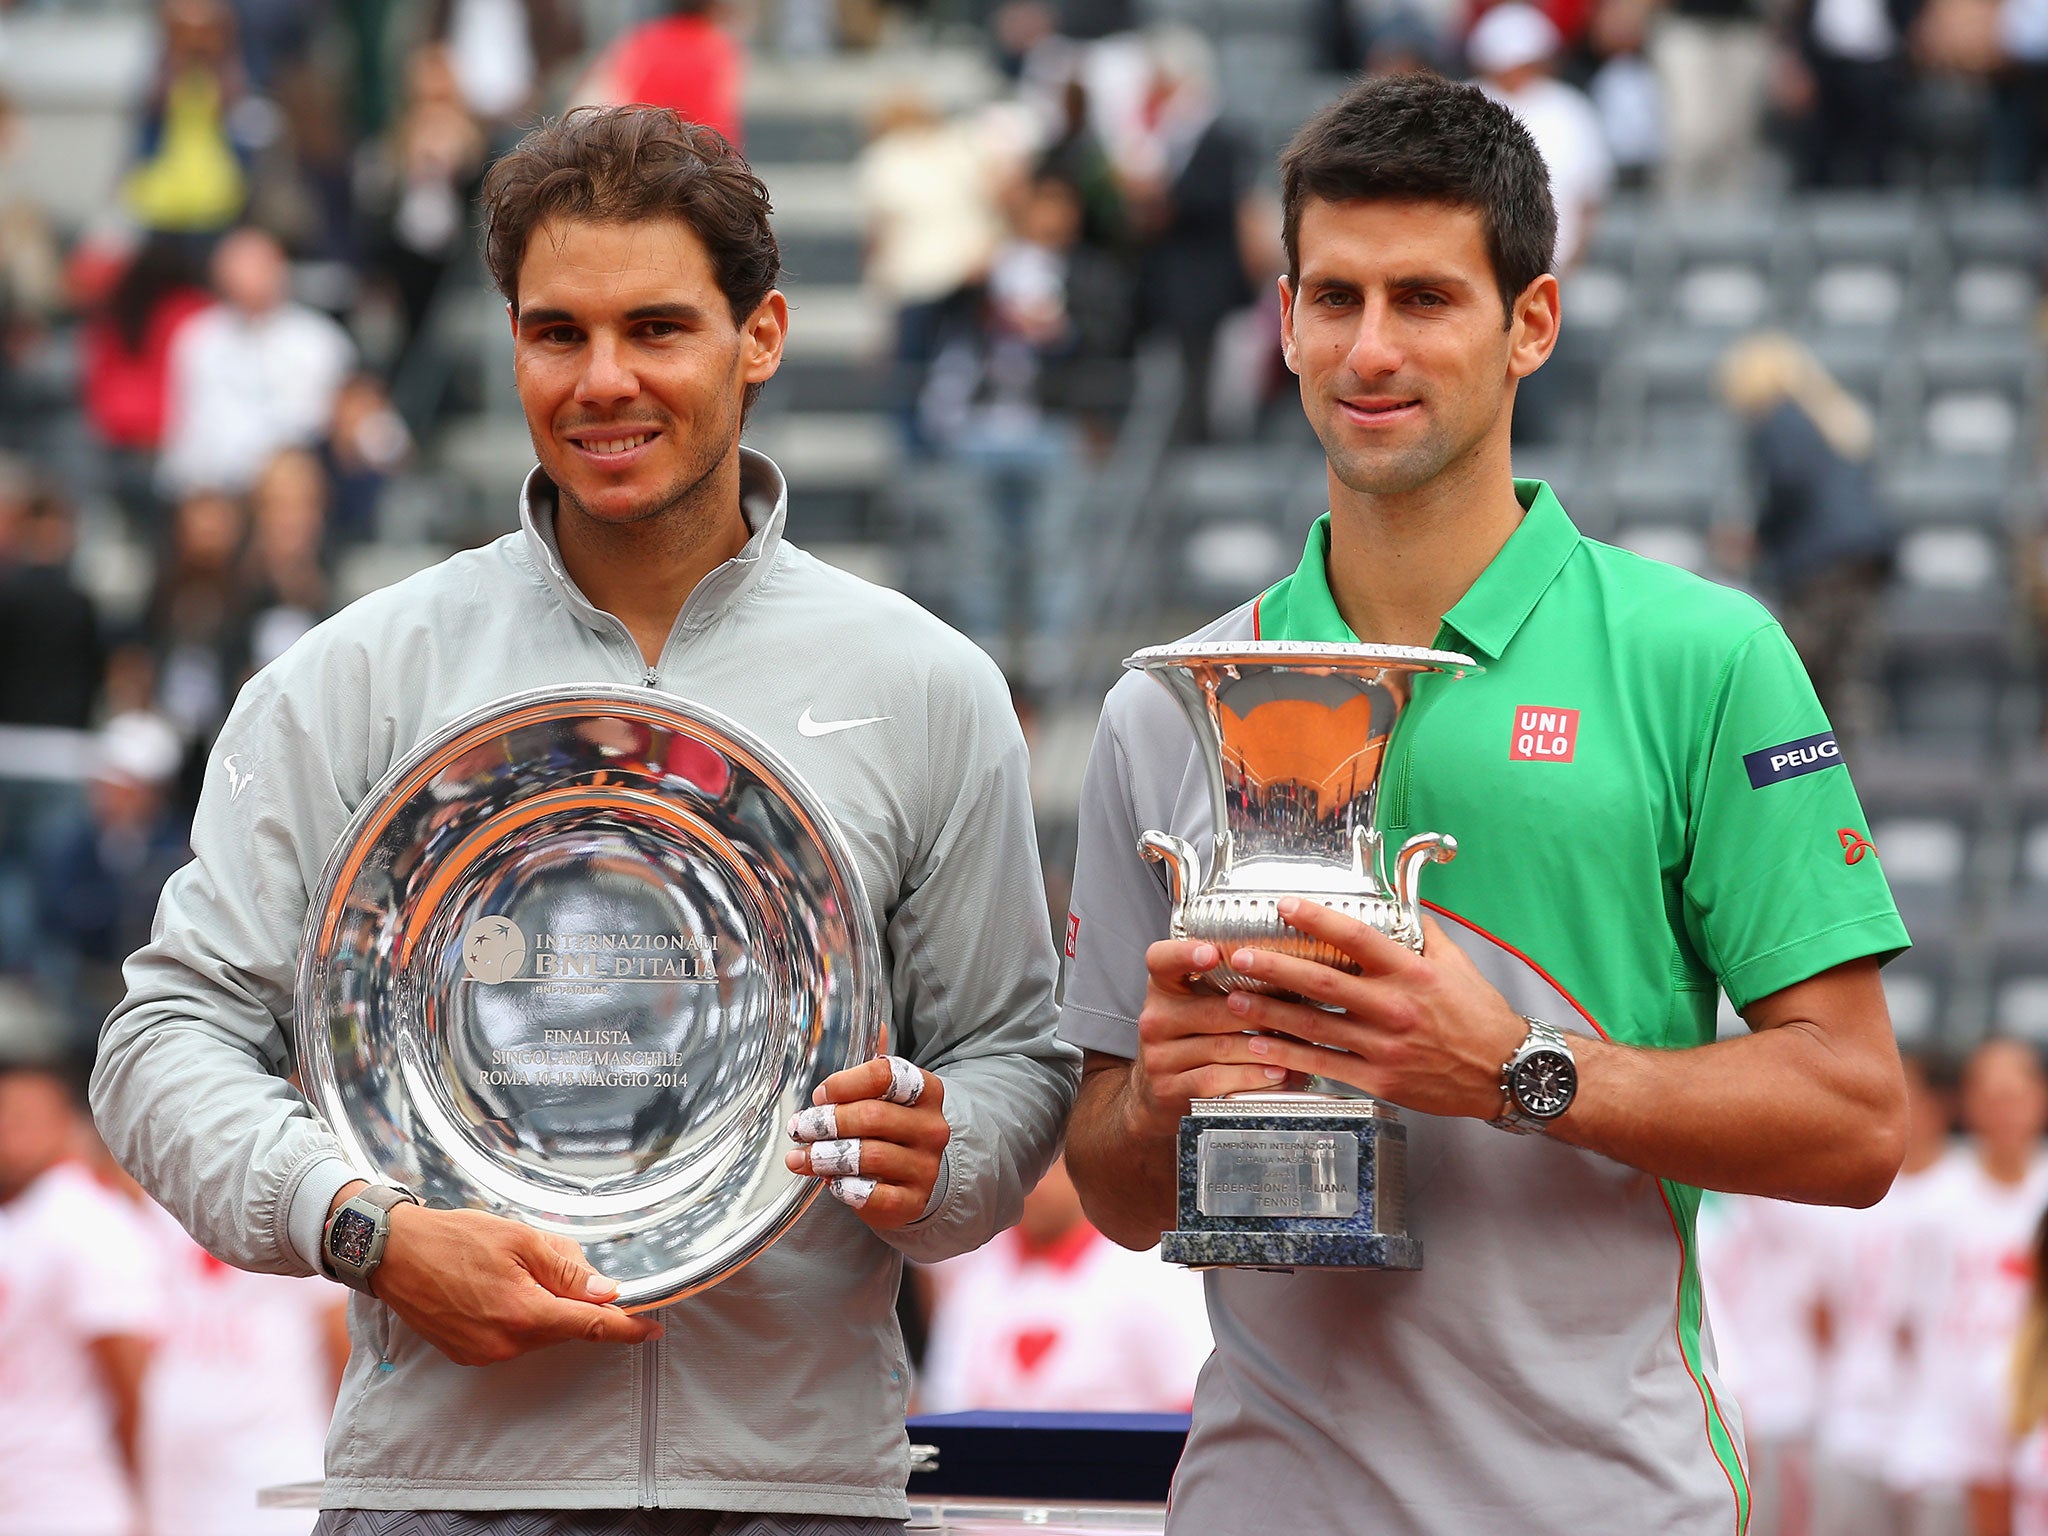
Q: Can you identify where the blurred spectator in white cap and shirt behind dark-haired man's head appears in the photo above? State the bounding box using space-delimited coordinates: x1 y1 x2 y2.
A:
1466 0 1614 276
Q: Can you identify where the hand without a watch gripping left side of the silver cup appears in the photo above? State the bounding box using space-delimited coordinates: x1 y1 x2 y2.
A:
1124 938 1288 1141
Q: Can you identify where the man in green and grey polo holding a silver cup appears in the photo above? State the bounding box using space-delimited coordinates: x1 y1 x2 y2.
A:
1061 78 1907 1536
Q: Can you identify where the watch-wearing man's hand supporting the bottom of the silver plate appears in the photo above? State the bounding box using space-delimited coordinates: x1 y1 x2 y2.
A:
336 1186 662 1366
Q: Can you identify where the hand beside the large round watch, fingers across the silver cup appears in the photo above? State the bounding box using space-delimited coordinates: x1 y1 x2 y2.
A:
1227 897 1528 1120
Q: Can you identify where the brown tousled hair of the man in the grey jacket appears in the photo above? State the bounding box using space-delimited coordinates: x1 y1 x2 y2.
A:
483 106 782 406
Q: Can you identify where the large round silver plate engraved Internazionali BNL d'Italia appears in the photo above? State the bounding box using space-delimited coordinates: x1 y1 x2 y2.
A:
297 688 885 1311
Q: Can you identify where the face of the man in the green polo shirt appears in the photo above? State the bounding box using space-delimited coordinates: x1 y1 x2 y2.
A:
1280 199 1556 496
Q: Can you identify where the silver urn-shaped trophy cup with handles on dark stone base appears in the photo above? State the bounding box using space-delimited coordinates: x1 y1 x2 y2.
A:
1124 641 1479 1270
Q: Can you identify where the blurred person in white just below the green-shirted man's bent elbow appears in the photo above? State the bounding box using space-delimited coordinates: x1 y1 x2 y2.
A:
1698 1194 1833 1536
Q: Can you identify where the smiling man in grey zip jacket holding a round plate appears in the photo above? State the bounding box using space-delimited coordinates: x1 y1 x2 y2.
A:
94 109 1077 1536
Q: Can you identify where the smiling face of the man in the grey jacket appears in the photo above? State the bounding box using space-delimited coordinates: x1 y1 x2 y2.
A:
512 219 788 526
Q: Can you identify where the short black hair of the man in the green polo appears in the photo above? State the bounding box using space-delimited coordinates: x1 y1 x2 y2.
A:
1280 74 1556 317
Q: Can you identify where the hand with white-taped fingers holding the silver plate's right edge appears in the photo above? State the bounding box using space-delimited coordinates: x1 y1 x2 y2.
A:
784 1057 952 1231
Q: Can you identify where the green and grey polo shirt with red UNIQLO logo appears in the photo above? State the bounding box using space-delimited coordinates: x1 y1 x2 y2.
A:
1061 481 1907 1536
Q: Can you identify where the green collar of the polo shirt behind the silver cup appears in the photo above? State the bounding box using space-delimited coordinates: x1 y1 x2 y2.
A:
1255 479 1579 662
